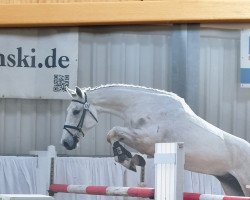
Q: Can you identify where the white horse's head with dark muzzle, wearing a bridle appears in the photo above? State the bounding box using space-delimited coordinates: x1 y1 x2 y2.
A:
61 87 98 150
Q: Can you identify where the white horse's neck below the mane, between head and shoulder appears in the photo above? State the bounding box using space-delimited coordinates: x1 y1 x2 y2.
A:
87 87 144 118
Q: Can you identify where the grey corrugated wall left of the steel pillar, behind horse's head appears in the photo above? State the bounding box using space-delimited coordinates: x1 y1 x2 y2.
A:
0 26 171 155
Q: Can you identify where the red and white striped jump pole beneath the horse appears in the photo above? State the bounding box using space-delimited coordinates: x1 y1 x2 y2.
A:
49 184 250 200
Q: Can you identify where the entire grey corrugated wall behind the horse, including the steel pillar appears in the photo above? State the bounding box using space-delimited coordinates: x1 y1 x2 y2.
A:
0 25 250 155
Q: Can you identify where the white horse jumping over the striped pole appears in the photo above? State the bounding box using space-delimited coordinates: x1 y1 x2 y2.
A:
61 84 250 196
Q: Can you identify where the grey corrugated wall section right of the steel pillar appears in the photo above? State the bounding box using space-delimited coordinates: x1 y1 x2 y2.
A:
199 30 250 141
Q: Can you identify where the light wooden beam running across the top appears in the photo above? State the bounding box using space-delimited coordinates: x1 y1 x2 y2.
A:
0 0 250 27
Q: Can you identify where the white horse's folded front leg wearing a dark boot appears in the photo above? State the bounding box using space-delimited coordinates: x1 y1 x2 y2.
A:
107 126 146 171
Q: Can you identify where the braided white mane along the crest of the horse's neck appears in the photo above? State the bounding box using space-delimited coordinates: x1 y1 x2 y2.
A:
82 83 173 95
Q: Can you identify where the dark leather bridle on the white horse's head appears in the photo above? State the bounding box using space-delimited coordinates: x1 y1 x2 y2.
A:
63 93 98 141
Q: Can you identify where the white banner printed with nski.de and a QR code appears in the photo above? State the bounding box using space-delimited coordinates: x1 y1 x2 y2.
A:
0 28 78 99
